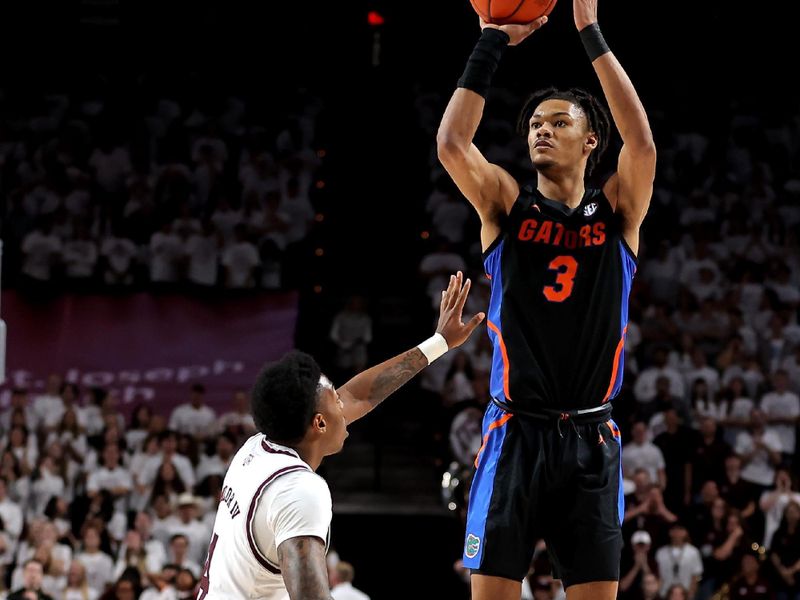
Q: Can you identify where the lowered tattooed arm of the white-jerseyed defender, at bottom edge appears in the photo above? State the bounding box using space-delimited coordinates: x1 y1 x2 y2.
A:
278 536 331 600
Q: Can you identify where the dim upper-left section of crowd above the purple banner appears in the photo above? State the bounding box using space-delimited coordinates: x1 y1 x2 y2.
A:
0 92 324 293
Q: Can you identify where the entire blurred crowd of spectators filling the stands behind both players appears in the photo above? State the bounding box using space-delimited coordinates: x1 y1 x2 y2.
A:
0 82 800 600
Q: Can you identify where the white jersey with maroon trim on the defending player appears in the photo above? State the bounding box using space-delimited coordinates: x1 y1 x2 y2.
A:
197 433 332 600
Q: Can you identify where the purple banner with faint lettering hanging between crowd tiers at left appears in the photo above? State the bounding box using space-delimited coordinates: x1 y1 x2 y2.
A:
0 291 297 415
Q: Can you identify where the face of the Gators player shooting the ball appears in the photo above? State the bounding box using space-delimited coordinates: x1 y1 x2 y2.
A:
528 100 596 171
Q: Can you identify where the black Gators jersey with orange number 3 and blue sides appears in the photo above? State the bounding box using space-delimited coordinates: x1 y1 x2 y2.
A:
483 186 636 410
